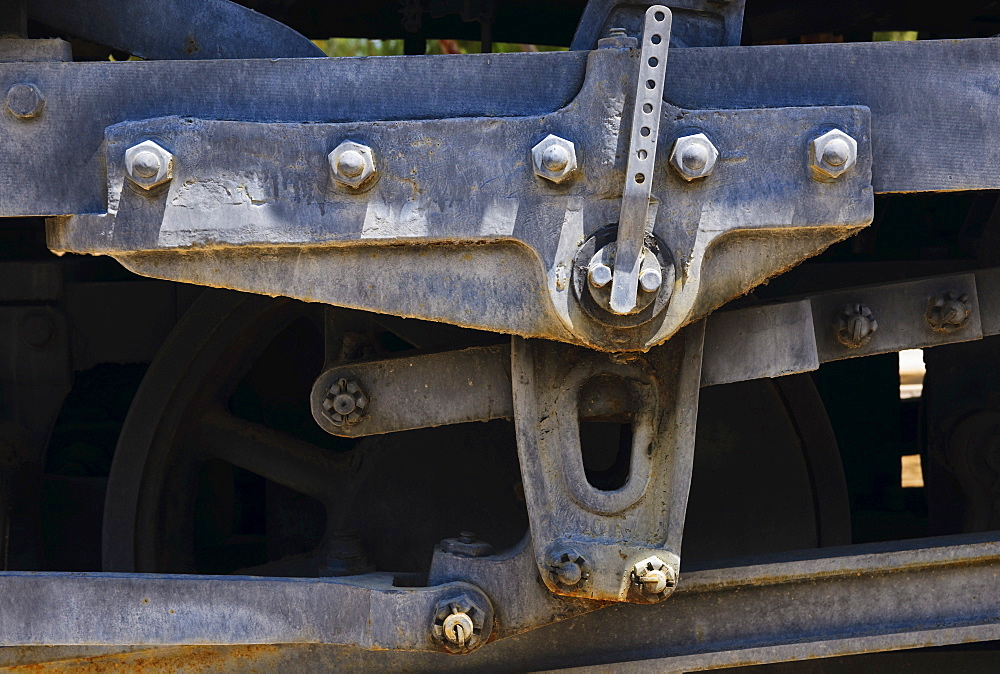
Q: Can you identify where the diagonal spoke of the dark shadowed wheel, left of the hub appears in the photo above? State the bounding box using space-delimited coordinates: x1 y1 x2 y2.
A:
190 409 348 503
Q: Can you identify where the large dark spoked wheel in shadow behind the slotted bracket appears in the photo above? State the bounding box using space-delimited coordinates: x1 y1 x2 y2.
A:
103 291 849 576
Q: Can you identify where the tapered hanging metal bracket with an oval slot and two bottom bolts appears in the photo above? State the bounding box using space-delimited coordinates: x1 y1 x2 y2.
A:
511 323 704 603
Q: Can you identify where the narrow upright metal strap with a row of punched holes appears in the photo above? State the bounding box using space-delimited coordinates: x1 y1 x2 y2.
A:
610 5 671 314
